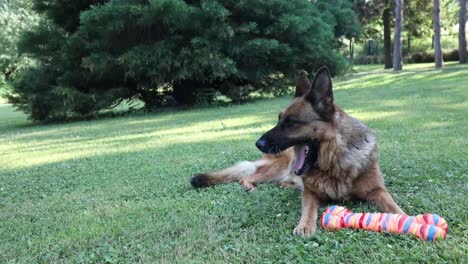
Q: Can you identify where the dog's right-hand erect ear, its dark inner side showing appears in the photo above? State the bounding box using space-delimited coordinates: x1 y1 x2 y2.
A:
306 67 335 120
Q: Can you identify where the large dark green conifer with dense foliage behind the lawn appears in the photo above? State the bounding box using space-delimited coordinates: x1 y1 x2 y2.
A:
9 0 360 120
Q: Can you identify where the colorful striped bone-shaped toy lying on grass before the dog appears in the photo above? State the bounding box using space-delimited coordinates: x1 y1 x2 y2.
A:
320 205 448 241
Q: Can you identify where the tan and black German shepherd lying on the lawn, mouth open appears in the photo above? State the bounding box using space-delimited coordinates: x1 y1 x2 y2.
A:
191 67 403 236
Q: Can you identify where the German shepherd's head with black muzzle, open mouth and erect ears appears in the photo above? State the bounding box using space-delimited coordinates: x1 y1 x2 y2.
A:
256 67 335 175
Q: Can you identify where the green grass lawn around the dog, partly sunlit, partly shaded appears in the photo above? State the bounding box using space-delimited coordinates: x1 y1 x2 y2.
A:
0 64 468 263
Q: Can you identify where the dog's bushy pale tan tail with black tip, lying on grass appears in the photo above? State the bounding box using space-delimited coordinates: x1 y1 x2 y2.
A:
190 161 260 188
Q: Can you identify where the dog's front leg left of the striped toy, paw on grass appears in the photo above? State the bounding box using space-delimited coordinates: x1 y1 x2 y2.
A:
293 188 320 237
